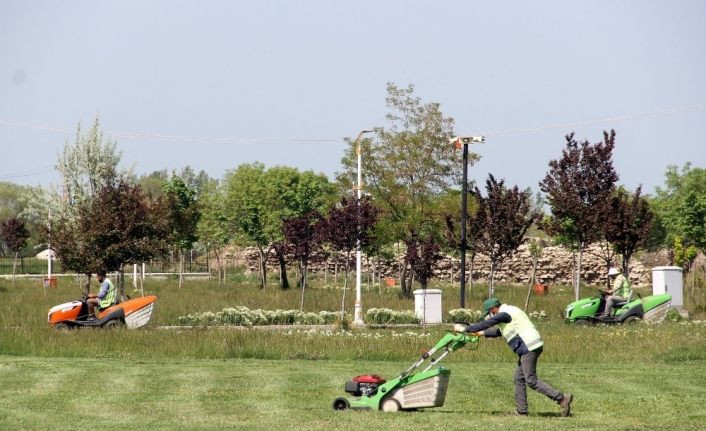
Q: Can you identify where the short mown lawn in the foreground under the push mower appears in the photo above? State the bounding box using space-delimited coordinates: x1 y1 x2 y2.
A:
0 358 706 430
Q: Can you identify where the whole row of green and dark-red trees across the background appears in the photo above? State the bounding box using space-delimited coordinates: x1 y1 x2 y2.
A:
0 84 706 304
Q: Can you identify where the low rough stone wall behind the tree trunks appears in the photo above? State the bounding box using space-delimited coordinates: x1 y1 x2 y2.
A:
223 241 669 287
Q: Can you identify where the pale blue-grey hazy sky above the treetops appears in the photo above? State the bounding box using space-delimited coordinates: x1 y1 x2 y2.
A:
0 0 706 193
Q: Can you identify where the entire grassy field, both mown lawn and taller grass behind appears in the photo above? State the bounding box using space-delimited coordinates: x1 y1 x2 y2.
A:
0 277 706 430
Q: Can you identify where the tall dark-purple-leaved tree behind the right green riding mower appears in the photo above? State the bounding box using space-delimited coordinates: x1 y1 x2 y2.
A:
539 130 618 300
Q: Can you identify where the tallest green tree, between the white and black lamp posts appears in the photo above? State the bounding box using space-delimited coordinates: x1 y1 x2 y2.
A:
338 84 477 297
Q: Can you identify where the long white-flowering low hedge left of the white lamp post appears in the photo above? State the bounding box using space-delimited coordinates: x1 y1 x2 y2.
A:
178 305 340 326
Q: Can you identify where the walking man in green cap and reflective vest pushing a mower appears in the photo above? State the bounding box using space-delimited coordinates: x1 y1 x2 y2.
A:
454 298 573 416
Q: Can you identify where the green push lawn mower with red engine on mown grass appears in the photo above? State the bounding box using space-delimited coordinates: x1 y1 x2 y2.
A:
333 332 478 412
